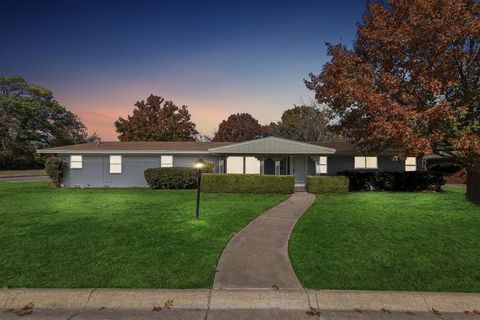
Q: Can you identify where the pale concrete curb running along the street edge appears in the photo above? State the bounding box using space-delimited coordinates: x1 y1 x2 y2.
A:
0 289 480 313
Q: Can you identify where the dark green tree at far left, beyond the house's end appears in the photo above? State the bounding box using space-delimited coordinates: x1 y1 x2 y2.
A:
0 76 91 169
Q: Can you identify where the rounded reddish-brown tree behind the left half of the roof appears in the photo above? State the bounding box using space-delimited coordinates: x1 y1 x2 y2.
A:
115 94 198 141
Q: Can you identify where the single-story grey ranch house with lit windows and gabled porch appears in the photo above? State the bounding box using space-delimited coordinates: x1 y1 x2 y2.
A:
37 137 423 187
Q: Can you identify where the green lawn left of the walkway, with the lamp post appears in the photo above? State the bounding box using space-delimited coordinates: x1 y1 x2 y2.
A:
0 182 286 288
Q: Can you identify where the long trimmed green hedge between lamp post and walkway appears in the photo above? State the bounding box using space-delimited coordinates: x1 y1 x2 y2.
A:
201 173 295 193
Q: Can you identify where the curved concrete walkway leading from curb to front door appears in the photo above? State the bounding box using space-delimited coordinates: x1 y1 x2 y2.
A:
213 192 315 289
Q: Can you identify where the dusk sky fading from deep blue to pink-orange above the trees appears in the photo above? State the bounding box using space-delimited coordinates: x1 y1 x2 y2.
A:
0 0 365 140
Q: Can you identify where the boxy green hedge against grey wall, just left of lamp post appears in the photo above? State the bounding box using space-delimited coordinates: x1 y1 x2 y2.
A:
144 164 213 189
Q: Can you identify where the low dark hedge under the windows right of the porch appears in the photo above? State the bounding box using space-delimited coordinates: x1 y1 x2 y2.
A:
338 171 445 191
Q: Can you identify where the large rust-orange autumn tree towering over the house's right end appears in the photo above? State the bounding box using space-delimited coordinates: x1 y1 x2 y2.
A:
305 0 480 204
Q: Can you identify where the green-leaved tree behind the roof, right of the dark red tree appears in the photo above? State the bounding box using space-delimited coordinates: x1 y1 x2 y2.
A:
267 102 338 141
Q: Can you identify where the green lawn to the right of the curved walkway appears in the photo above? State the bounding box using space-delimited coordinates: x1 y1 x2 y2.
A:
289 187 480 292
